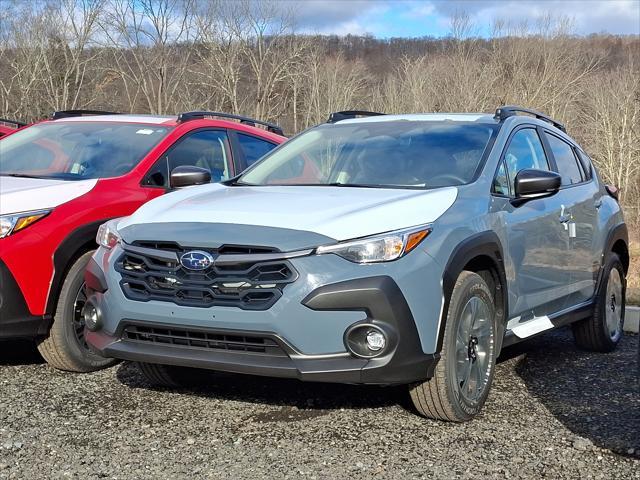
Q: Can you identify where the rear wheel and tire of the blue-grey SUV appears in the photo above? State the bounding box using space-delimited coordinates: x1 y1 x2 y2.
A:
572 253 626 352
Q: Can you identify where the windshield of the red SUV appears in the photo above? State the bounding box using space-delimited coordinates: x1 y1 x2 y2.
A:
0 122 169 180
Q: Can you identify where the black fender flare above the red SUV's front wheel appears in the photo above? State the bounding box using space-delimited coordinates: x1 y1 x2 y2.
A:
45 217 114 316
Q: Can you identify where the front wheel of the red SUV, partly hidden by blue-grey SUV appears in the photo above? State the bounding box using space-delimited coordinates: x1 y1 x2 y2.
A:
38 251 117 372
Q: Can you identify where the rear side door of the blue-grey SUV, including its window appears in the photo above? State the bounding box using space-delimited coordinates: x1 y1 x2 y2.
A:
544 129 600 307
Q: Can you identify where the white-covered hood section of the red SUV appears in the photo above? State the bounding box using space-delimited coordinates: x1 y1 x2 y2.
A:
0 176 98 215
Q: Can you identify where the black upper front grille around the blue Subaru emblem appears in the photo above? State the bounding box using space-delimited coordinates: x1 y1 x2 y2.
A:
115 242 298 310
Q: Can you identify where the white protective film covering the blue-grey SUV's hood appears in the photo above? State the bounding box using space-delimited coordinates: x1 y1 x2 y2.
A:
118 184 458 243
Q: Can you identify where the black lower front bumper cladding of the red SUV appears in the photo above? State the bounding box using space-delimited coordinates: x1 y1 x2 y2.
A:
0 259 50 339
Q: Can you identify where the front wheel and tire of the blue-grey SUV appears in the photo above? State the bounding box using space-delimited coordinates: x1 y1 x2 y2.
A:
410 271 497 422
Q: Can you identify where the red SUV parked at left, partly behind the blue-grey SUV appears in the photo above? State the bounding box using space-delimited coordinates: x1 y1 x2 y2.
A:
0 110 285 372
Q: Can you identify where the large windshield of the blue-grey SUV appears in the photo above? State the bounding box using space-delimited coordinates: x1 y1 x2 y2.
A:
236 120 497 188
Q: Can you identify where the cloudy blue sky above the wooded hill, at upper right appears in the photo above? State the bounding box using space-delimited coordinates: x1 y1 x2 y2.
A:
288 0 640 38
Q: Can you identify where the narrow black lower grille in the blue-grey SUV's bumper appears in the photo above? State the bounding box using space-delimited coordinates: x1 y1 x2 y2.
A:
122 325 287 357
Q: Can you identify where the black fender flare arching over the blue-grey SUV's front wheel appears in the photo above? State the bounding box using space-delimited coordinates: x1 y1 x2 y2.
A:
436 231 509 353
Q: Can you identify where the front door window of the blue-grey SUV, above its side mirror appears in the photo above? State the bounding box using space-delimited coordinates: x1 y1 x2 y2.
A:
494 128 549 193
